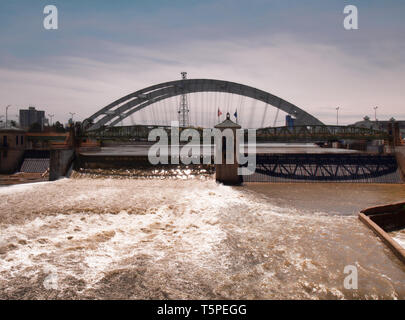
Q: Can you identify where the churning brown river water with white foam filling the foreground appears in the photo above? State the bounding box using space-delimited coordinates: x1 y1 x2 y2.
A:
0 178 405 299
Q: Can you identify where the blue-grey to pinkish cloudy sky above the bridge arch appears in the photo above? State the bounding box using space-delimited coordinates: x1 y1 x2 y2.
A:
0 0 405 124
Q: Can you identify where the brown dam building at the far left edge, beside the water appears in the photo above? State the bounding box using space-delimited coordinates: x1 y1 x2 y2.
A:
0 127 26 173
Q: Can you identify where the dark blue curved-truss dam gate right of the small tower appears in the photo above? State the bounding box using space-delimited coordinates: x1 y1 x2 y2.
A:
243 154 401 183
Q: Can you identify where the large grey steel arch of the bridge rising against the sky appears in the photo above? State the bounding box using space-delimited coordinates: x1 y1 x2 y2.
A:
83 79 324 131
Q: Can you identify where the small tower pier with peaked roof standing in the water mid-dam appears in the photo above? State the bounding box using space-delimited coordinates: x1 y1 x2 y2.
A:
215 113 242 185
